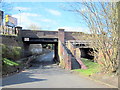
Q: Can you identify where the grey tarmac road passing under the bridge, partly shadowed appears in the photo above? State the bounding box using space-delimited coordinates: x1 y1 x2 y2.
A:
2 52 110 88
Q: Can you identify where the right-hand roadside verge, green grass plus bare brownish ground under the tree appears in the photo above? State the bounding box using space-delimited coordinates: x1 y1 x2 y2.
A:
73 58 118 87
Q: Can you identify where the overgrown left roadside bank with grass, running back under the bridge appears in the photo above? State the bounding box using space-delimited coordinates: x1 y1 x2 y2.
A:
0 44 51 77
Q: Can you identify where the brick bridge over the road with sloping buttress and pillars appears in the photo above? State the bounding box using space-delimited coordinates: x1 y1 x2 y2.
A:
17 27 91 69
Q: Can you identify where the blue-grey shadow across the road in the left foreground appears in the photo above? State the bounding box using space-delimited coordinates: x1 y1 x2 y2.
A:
2 69 47 86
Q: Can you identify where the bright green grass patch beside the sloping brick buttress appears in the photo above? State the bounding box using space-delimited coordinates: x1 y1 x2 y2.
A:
73 58 101 76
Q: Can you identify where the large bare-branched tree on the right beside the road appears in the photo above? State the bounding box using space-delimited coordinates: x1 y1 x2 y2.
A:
67 2 119 72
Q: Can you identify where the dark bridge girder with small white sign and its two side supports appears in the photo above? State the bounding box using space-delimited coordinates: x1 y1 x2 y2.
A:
22 38 59 63
